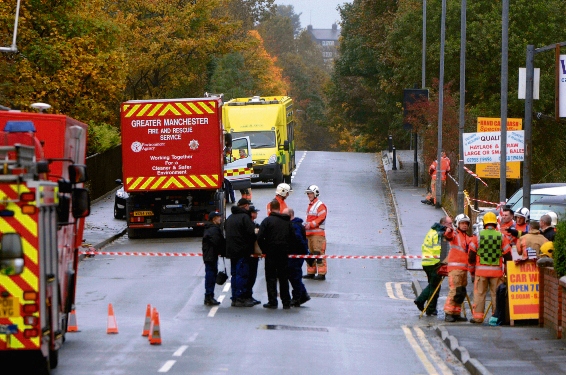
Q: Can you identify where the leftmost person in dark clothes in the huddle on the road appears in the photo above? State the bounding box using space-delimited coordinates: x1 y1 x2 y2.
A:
202 211 226 306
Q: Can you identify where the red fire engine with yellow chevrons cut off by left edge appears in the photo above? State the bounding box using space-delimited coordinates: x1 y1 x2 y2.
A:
0 110 90 374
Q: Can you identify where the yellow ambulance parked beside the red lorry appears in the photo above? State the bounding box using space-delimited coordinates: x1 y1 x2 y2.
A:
222 96 295 186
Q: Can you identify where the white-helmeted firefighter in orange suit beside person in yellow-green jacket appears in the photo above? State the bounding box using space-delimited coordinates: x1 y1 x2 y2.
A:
444 214 478 322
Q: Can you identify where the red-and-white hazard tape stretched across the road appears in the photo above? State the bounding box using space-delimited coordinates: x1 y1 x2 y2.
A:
79 251 440 259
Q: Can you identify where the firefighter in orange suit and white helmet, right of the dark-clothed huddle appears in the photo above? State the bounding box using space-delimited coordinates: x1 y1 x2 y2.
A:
303 185 327 280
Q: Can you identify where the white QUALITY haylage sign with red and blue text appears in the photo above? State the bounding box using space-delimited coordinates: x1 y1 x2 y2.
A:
464 130 525 164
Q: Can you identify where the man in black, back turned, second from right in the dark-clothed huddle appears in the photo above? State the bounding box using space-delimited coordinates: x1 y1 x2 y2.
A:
257 199 293 309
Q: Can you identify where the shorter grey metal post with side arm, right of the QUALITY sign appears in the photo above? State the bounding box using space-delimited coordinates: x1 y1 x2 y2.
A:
523 44 535 210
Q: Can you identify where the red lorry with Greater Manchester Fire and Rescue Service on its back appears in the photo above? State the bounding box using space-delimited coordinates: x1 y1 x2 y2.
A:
121 96 252 238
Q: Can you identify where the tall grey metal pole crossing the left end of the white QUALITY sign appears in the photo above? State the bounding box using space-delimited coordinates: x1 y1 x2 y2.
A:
456 0 468 213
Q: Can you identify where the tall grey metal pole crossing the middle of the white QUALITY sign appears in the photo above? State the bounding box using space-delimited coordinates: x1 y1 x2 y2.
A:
499 0 510 202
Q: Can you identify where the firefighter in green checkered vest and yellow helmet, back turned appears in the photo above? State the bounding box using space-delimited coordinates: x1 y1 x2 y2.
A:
468 212 512 324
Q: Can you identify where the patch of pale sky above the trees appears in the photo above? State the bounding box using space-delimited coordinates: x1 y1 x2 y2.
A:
275 0 352 29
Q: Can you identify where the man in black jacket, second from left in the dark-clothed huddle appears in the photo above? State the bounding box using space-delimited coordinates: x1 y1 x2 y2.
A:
224 198 256 307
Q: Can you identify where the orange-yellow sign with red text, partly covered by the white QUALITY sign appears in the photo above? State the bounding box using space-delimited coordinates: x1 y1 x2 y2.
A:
476 117 523 179
